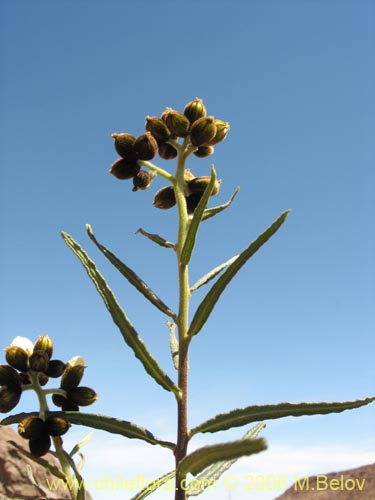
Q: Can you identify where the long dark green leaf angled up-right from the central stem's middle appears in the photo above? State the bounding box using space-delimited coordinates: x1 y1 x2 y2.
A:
188 210 290 337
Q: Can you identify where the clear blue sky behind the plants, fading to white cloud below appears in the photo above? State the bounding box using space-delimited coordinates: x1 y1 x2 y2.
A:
0 0 375 500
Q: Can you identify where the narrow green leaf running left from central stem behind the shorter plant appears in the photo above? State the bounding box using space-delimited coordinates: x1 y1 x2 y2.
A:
1 411 175 451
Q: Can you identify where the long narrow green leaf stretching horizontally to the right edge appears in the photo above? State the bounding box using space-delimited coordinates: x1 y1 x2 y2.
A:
190 397 375 436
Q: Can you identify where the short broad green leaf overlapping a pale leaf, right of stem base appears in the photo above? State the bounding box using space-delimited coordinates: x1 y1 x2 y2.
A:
178 438 267 476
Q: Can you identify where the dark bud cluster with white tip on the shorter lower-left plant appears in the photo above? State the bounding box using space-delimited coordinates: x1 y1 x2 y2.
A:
0 335 98 456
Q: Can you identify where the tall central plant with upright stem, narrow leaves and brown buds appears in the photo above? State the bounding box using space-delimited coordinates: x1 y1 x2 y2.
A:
0 98 375 500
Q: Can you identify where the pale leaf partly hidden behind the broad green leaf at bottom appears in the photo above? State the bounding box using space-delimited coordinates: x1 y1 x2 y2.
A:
186 422 266 497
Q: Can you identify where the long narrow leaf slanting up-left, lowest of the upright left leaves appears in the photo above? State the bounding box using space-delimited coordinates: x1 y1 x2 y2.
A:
62 233 181 398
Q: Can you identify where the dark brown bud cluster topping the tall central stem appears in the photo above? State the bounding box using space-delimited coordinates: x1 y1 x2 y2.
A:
110 98 230 214
